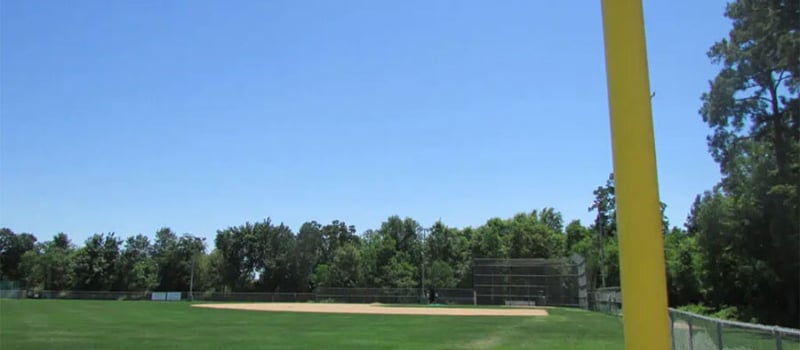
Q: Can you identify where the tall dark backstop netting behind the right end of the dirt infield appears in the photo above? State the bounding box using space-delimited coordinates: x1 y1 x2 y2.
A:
472 258 585 306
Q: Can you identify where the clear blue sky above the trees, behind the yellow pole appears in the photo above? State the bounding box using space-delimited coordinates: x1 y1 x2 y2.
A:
0 0 730 243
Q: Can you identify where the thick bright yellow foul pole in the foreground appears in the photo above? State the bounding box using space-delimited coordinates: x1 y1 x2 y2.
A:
603 0 670 350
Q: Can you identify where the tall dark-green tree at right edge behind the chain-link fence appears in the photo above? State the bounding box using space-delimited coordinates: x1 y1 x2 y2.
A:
693 0 800 325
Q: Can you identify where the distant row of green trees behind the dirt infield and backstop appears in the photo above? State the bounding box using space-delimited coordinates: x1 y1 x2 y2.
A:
0 208 576 292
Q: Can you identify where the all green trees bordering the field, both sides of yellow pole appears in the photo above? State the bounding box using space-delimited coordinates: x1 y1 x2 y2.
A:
0 0 800 326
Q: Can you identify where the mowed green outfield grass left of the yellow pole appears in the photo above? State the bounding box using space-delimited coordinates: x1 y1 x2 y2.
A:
0 300 623 350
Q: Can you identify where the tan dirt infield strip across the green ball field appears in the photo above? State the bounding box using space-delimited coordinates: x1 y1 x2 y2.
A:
192 303 548 316
